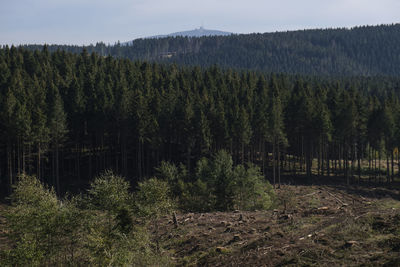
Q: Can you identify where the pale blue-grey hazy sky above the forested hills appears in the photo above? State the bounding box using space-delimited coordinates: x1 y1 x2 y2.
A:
0 0 400 45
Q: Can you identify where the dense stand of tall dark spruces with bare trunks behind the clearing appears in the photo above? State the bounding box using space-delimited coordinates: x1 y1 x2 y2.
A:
0 47 400 196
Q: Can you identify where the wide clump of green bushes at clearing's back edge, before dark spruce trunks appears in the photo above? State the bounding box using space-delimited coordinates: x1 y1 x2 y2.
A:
153 150 275 212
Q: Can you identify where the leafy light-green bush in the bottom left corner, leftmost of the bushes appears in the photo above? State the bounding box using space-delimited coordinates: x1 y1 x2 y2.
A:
6 175 61 265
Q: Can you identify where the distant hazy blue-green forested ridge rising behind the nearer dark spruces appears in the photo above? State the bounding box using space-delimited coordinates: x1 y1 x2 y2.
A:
18 24 400 76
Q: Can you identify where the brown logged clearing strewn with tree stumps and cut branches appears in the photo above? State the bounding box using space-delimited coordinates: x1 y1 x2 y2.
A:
152 186 400 266
